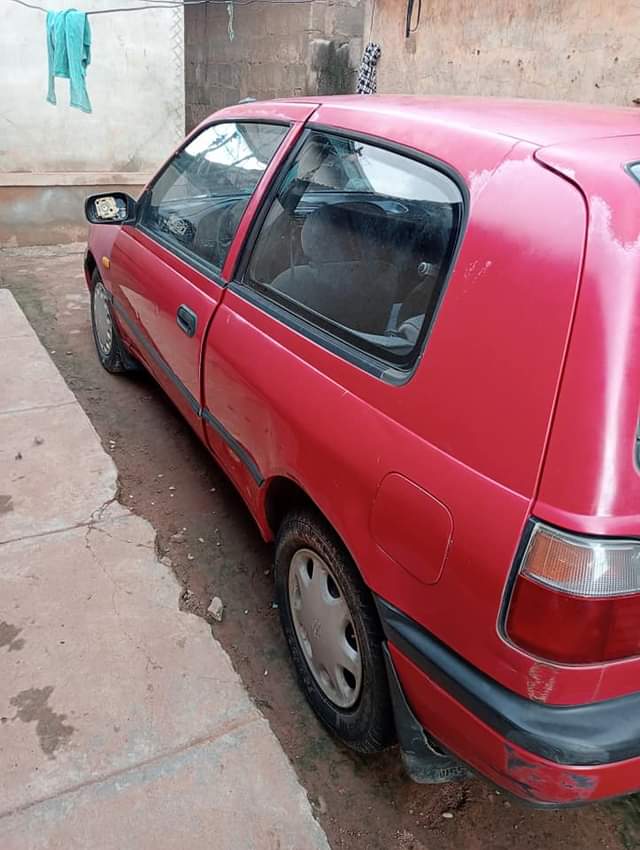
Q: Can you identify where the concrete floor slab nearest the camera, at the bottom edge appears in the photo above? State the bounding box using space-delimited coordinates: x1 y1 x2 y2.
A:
0 720 329 850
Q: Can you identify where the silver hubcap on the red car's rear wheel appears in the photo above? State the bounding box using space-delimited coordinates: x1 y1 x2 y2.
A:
288 549 362 708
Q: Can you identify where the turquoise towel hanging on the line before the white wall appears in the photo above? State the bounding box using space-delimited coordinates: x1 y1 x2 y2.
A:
47 9 91 112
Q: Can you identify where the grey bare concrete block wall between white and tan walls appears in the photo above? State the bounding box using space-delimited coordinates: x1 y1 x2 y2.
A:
185 0 366 129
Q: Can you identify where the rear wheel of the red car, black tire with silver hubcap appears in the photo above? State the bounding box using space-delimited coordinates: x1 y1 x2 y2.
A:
275 511 394 753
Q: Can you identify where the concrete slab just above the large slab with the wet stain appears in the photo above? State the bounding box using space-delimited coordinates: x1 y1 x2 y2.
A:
0 400 118 543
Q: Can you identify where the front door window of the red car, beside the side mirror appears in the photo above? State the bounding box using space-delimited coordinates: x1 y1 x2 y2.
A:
139 122 288 271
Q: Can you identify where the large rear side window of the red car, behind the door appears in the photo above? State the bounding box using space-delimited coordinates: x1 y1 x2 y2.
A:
243 131 463 368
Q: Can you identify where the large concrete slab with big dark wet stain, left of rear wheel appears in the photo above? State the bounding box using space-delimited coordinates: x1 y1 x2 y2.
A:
0 515 258 812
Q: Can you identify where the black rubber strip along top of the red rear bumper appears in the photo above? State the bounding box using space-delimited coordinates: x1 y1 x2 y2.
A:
376 597 640 766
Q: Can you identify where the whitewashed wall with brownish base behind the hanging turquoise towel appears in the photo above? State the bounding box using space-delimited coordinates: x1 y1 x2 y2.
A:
0 0 184 245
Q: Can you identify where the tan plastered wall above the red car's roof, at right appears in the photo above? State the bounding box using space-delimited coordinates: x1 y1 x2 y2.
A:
365 0 640 107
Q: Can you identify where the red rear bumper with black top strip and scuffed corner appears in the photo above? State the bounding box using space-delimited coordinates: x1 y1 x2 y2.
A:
377 599 640 806
